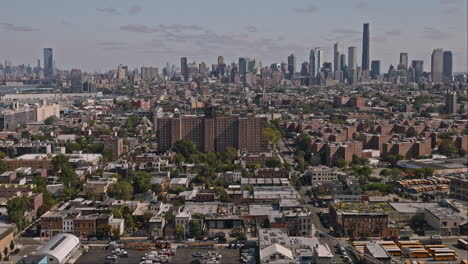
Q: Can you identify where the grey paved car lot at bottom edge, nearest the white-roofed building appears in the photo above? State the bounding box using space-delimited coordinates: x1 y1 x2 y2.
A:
170 248 241 264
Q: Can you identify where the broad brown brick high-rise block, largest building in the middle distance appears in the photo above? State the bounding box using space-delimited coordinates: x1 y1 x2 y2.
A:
156 116 266 153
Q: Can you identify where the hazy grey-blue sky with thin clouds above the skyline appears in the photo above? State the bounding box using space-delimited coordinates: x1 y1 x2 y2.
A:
0 0 468 72
